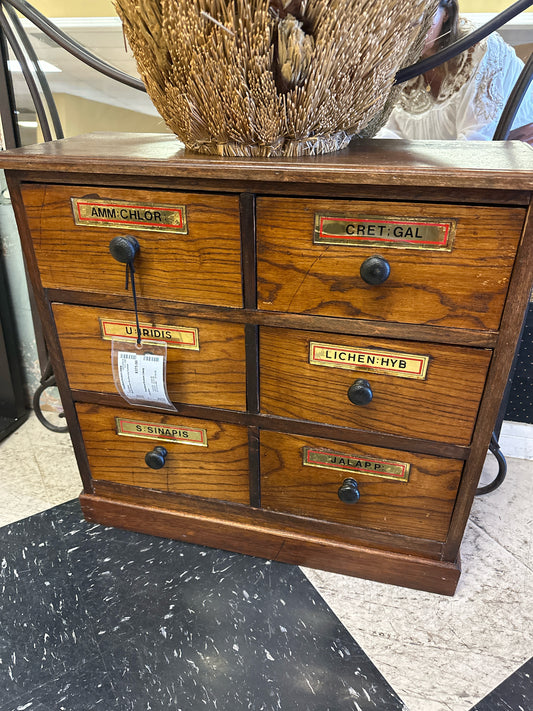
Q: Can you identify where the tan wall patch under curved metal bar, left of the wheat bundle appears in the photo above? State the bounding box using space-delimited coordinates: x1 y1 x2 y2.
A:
50 94 170 138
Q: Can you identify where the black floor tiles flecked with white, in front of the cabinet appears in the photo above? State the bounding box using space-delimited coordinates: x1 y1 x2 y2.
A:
0 501 533 711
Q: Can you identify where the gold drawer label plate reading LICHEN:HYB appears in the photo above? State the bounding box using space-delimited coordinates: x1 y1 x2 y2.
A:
309 341 429 380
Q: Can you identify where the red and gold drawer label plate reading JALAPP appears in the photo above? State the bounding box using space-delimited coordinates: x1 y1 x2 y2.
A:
302 447 411 481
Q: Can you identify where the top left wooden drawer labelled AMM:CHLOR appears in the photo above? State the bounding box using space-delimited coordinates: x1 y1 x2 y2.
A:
22 184 242 307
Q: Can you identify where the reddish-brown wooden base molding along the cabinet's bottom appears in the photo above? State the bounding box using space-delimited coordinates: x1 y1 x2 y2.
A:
80 494 461 596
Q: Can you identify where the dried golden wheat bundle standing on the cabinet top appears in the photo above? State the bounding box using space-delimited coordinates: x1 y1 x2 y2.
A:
115 0 437 156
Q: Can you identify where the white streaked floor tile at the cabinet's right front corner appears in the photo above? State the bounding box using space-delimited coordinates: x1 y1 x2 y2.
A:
304 459 533 711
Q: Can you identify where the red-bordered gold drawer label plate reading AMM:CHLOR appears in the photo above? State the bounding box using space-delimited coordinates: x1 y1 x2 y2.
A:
71 198 188 235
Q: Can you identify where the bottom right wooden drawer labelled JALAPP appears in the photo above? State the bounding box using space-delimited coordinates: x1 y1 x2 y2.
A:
261 431 463 541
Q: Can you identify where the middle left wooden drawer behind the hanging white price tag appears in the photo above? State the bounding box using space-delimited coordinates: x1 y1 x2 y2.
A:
53 304 246 410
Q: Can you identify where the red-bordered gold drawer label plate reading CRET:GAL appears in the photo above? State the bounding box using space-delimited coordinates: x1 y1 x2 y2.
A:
313 214 457 252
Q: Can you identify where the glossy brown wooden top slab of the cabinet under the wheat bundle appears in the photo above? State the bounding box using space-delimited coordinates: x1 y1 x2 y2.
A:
0 133 533 190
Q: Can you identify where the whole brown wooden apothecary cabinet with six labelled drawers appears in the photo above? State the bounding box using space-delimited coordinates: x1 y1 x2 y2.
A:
2 134 533 594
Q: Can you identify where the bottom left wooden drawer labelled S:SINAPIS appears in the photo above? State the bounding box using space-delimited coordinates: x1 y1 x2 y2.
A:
76 403 250 504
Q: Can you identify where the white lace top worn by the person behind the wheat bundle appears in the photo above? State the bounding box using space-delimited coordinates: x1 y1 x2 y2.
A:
376 20 533 141
